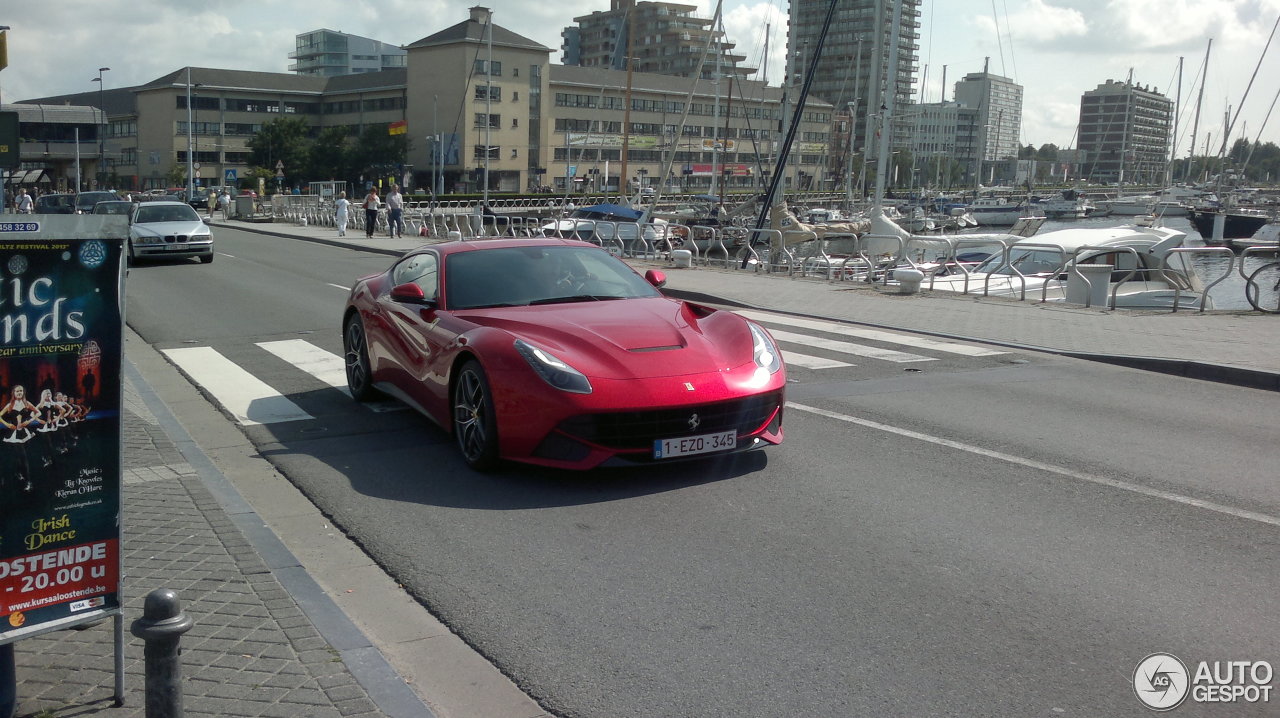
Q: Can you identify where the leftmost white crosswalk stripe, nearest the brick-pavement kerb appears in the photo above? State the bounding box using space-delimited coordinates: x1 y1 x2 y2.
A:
164 347 314 424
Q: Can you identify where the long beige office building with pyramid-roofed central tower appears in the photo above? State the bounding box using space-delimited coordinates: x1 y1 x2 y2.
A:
10 8 832 193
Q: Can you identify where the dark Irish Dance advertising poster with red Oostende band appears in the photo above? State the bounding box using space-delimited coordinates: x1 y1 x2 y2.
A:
0 230 123 644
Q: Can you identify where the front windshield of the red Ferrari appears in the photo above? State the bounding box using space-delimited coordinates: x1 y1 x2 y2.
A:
444 247 660 310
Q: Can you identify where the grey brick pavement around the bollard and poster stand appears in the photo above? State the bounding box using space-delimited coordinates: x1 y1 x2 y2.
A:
8 371 383 718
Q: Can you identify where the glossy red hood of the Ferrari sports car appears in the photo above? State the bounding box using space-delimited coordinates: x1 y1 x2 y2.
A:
460 297 751 379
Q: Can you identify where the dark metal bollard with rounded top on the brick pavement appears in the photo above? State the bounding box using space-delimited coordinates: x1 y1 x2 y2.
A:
129 589 196 718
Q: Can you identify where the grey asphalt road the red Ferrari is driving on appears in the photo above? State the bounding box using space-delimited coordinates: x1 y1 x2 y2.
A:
128 229 1280 718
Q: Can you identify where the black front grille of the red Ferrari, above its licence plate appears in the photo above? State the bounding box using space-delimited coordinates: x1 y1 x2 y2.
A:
556 392 782 449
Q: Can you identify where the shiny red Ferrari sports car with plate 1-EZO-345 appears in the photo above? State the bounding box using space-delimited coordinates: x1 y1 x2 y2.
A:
342 238 786 471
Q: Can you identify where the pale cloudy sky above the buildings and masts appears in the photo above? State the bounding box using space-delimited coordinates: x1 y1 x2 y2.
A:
0 0 1280 156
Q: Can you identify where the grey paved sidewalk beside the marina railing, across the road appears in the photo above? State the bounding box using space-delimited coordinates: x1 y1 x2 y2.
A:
215 215 1280 390
